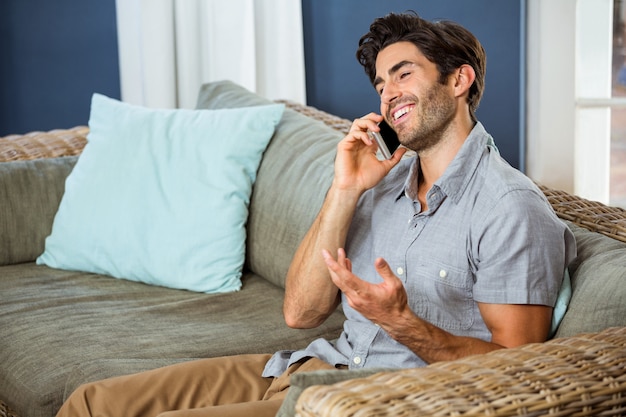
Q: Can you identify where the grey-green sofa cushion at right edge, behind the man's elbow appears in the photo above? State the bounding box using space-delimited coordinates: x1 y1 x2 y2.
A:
555 222 626 337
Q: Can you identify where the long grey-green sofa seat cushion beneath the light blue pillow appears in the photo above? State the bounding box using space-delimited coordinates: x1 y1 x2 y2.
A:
0 263 343 417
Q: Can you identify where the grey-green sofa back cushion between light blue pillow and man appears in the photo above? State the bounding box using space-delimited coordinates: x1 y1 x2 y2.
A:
198 81 343 287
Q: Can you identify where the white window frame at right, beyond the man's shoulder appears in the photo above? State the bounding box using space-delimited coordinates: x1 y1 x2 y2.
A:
526 0 612 204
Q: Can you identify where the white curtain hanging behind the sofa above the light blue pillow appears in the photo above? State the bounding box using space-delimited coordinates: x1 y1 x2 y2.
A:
116 0 306 108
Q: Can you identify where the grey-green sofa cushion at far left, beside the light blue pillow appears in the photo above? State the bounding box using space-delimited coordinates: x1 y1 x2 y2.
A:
0 157 76 265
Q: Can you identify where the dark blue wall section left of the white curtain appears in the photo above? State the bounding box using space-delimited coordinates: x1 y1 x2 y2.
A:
0 0 120 136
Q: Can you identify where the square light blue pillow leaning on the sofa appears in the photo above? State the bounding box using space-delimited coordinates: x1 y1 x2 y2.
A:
37 94 284 293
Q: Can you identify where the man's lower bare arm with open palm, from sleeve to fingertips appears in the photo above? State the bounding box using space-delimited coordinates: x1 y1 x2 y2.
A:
324 249 552 363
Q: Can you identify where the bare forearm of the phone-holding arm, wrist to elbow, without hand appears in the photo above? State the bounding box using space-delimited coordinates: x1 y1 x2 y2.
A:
283 187 358 328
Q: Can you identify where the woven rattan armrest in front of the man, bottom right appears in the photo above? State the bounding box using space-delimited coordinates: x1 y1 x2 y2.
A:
296 328 626 417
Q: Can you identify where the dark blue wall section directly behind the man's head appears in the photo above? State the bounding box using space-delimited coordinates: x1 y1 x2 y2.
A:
302 0 526 168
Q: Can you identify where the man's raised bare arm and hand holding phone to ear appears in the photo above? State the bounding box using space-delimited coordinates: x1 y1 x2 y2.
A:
283 114 405 328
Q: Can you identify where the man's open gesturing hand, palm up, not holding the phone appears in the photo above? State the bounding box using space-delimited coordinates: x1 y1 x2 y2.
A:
322 248 413 329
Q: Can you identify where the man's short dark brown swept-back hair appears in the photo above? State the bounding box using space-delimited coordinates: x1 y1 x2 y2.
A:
356 12 487 119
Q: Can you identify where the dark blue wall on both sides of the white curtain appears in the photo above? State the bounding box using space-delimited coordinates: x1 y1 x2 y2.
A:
0 0 526 168
